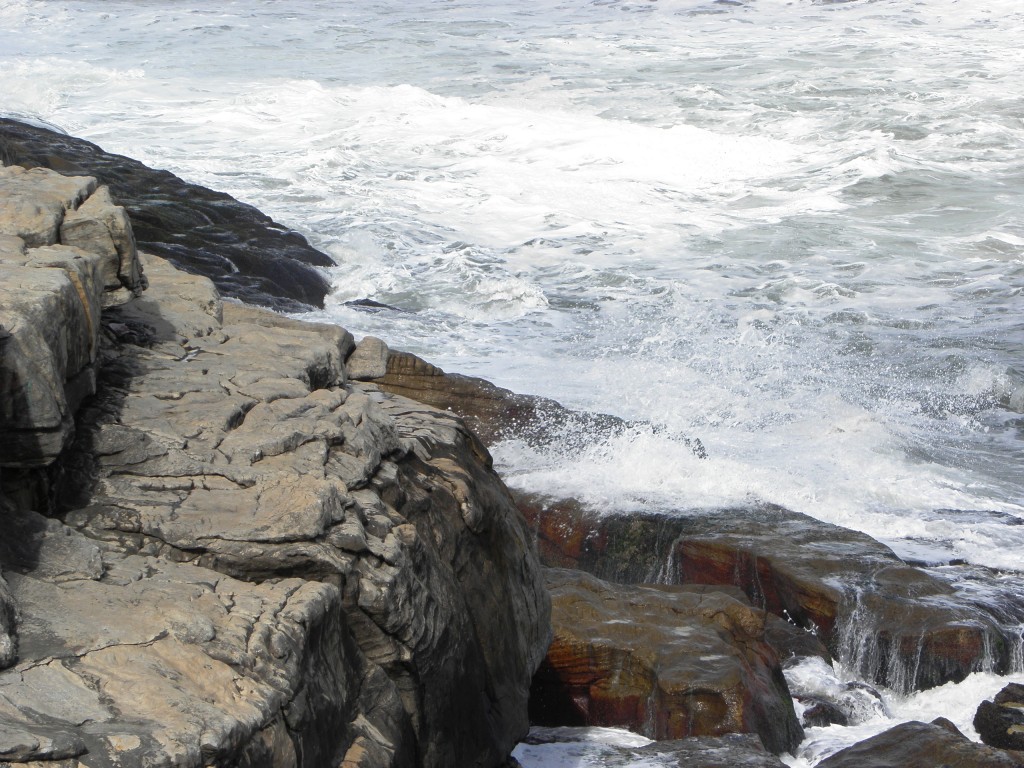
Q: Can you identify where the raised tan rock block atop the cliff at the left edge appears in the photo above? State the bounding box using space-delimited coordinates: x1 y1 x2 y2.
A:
0 166 145 467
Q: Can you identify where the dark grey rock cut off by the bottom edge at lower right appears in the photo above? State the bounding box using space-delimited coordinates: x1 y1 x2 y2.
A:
817 719 1024 768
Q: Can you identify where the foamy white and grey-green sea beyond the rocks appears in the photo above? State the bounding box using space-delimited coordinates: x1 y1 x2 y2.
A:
0 0 1024 761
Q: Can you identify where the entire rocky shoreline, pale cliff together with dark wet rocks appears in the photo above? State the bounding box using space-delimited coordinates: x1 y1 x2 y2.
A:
0 120 1024 768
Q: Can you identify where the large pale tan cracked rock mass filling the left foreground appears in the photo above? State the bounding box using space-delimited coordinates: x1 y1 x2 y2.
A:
0 169 550 767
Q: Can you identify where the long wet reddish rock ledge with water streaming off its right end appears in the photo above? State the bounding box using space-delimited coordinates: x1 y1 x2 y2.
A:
519 495 1012 692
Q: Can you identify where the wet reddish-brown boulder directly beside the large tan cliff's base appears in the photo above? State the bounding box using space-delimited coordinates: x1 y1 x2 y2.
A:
530 569 803 753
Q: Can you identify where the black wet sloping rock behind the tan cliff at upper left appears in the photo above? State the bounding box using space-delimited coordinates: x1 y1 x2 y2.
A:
0 118 334 311
